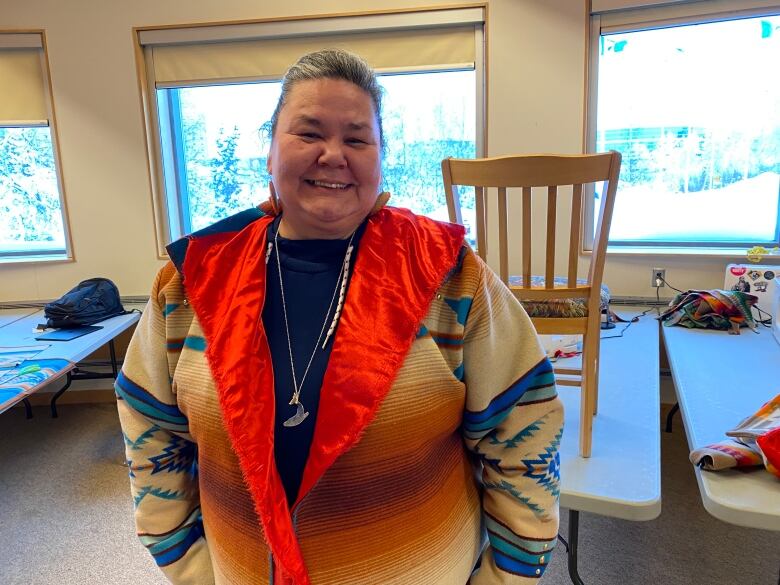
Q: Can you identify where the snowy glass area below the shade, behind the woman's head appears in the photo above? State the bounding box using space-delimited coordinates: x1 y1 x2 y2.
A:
157 70 476 237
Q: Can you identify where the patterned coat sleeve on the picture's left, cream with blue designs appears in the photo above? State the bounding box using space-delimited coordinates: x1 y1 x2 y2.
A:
115 265 214 585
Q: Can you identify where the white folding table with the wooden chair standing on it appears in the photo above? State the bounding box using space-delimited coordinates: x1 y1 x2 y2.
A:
558 308 661 585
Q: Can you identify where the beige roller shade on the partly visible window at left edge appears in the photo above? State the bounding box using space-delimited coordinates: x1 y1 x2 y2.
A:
0 35 49 124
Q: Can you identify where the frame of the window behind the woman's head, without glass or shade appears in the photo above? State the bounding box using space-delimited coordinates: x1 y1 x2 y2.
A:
134 3 487 254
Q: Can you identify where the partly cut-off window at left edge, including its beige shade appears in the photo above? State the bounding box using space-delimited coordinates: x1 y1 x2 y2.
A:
0 33 69 262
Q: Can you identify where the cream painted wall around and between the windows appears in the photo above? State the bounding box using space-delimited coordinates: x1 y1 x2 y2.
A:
0 0 752 302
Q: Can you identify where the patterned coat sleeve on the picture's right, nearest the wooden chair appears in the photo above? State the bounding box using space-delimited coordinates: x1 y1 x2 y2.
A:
462 252 563 585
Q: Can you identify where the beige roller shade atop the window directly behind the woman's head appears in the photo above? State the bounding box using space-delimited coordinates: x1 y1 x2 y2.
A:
139 8 484 88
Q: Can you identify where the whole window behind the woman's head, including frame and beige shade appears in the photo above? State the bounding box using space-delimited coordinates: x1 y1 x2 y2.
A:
139 9 482 249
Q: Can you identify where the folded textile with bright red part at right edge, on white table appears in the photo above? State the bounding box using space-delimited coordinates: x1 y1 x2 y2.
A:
690 394 780 477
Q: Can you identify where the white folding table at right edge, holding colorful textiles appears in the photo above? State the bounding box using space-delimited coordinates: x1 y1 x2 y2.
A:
663 327 780 531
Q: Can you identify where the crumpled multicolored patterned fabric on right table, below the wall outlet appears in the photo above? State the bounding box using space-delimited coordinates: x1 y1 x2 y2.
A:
659 289 758 335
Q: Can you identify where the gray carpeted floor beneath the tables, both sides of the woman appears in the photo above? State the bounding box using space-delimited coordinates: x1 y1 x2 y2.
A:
0 404 780 585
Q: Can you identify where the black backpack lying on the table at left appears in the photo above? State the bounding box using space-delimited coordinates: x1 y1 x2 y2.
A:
43 278 127 329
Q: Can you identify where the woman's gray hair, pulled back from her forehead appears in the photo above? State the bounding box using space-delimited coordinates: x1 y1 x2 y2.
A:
271 49 385 147
